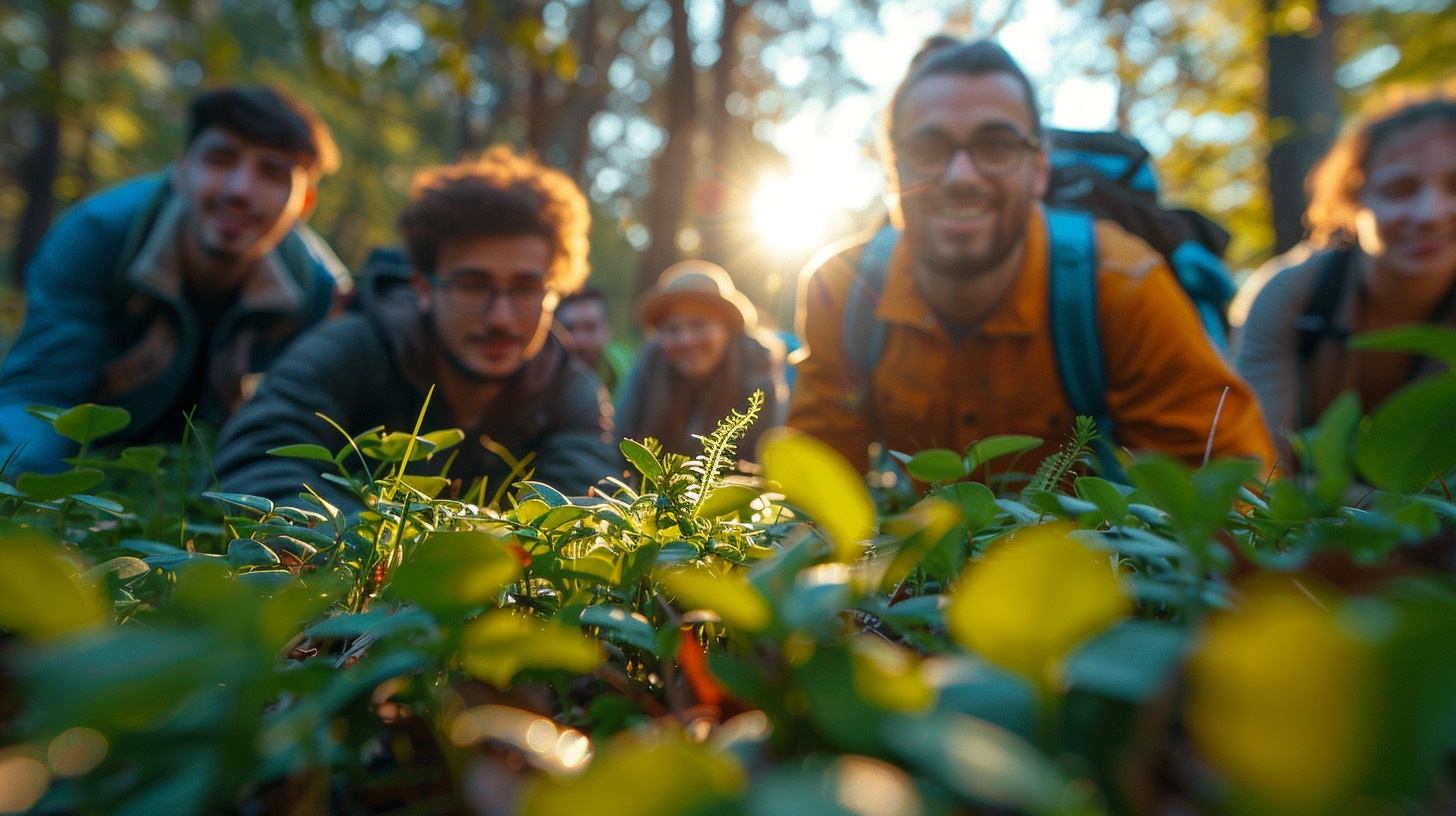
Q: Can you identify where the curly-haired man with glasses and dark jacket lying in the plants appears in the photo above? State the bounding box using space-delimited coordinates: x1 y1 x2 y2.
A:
217 147 619 507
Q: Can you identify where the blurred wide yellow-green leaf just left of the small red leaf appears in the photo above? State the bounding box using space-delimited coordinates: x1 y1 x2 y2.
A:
460 609 606 688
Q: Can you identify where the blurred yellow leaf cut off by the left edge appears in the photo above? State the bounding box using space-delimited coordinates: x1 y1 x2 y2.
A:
0 538 109 640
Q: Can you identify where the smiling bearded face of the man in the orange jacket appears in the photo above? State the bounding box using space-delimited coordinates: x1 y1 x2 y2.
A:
893 73 1050 287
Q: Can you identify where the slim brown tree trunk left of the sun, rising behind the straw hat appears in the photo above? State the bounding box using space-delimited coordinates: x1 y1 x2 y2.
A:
636 0 697 291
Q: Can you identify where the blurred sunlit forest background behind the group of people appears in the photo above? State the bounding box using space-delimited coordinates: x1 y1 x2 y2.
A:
0 0 1456 335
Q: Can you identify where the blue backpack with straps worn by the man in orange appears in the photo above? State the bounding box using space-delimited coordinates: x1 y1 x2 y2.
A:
844 131 1236 475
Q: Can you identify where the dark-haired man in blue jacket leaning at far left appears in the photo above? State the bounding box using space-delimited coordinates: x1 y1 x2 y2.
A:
0 87 347 475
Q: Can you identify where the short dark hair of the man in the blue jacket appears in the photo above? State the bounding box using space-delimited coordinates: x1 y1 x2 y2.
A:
186 85 339 179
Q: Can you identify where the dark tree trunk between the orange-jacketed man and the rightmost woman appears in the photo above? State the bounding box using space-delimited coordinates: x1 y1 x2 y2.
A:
1268 0 1340 252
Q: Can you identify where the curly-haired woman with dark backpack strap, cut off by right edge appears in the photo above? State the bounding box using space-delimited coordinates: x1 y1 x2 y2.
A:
1238 93 1456 469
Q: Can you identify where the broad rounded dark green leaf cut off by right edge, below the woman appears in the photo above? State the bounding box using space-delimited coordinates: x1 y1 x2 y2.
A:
1356 374 1456 493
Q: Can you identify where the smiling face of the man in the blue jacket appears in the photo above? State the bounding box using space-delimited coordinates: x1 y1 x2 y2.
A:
173 127 314 271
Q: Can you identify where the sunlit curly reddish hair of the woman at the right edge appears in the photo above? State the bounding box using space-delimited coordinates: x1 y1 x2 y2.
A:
1305 85 1456 248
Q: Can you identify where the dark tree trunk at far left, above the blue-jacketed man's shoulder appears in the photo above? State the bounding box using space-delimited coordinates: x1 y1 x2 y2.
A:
10 3 71 287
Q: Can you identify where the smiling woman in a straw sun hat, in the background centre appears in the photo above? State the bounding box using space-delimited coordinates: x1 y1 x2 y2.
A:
616 261 788 460
